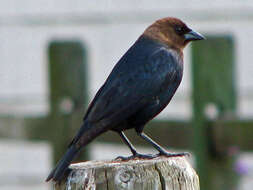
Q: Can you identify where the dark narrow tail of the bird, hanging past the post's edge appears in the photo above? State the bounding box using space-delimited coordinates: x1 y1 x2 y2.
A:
46 145 80 181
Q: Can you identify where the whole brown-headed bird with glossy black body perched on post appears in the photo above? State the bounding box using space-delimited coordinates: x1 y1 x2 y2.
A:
46 17 204 181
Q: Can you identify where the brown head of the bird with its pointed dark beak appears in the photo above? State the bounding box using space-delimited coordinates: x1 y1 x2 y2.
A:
143 17 205 50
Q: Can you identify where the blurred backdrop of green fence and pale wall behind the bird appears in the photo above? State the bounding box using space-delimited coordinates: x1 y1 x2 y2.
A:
0 0 253 190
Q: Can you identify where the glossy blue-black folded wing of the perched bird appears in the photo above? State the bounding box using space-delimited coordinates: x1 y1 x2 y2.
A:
85 47 178 126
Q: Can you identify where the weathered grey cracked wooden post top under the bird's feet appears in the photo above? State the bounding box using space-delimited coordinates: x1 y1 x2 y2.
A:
54 157 199 190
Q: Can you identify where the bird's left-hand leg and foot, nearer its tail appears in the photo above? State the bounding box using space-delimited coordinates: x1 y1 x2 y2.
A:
116 131 155 160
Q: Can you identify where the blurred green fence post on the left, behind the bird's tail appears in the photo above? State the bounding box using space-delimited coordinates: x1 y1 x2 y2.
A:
48 41 87 162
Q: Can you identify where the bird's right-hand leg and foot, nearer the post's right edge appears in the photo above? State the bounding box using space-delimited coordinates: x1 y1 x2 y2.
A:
137 132 189 157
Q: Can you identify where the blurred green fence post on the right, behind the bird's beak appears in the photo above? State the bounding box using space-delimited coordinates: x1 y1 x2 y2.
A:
192 36 237 190
